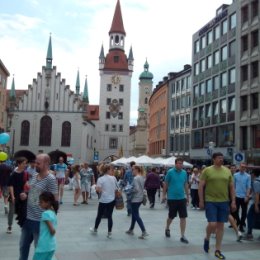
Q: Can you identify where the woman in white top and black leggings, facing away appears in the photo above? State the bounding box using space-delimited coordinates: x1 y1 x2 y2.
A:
90 165 118 238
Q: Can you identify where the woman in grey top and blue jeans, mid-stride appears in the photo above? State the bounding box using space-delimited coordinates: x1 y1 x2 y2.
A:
126 165 148 239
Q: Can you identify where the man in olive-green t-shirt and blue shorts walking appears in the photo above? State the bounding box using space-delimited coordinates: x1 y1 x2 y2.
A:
199 152 236 259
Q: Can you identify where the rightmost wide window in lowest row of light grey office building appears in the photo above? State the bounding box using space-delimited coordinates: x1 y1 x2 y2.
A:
217 124 235 147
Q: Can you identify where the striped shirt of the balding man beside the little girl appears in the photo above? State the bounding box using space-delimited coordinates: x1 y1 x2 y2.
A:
27 173 58 221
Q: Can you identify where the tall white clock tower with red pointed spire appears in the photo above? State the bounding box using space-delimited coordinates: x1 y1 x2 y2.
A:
95 0 134 160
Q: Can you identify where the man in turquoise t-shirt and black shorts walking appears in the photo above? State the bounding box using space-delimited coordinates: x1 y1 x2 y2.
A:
162 158 189 244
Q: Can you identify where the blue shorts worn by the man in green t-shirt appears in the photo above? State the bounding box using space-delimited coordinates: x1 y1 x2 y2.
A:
205 201 230 223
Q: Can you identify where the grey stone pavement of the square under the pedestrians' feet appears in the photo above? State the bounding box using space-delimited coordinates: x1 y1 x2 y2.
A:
0 189 260 260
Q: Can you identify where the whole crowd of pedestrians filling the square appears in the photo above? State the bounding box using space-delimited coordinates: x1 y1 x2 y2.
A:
0 153 260 260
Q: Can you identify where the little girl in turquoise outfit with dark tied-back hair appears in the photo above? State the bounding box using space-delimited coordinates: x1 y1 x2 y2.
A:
33 191 58 260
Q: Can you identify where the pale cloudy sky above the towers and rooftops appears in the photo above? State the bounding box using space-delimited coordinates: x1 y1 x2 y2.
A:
0 0 232 125
